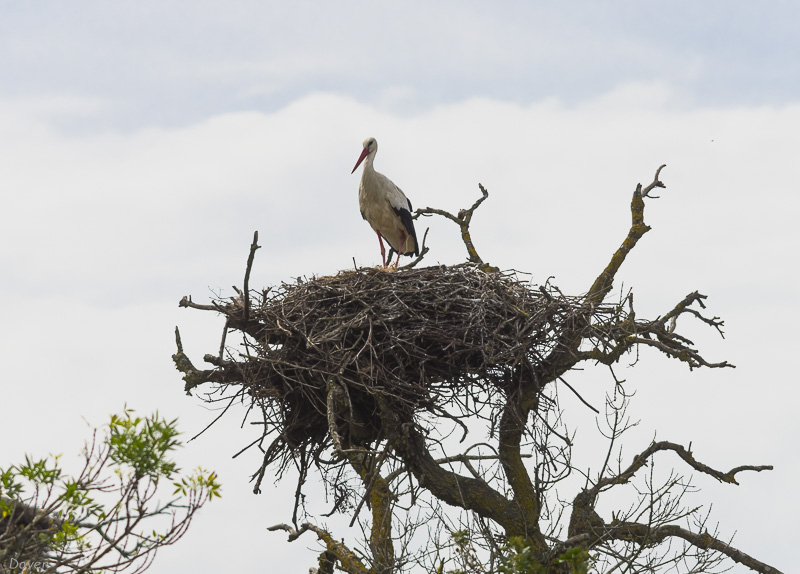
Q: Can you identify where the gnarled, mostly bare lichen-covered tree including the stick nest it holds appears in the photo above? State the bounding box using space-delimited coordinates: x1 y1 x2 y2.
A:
173 170 778 574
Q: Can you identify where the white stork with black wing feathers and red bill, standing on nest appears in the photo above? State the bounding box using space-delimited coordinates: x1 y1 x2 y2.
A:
350 138 419 269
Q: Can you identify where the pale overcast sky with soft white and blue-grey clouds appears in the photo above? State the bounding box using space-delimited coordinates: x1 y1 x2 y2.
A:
0 1 800 574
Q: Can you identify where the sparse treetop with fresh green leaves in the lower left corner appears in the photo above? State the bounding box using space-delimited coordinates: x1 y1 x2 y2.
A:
0 409 221 573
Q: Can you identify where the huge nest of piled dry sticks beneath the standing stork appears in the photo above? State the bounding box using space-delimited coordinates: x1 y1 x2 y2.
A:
187 264 610 472
